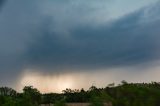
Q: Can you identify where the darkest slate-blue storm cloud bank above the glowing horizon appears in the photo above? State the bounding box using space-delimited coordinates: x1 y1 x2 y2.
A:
25 2 160 69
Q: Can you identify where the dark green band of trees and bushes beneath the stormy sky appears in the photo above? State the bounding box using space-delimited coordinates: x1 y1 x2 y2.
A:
0 81 160 106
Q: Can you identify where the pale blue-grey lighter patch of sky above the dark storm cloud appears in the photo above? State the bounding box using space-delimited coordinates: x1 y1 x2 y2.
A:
41 0 157 23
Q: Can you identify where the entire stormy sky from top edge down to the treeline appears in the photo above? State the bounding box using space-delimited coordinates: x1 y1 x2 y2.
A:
0 0 160 93
